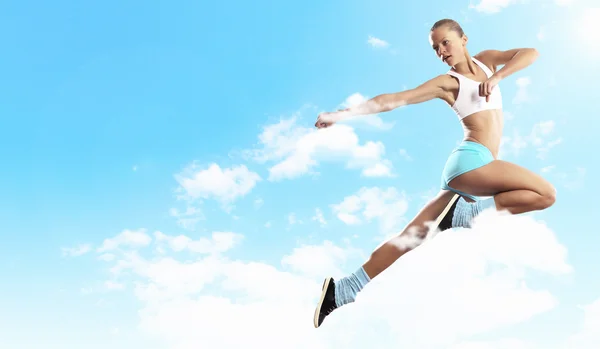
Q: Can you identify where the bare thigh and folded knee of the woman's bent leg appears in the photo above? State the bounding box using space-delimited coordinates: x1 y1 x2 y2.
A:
448 160 556 214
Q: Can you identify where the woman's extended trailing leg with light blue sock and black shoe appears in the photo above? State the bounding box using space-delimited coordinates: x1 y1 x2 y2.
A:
314 190 457 327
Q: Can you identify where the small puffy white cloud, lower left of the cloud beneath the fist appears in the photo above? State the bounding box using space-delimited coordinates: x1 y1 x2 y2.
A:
175 163 261 210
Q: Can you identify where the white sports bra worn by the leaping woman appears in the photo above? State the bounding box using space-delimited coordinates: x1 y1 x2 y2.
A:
447 57 502 120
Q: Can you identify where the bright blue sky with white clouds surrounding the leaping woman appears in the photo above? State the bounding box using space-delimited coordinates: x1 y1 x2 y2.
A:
0 0 600 349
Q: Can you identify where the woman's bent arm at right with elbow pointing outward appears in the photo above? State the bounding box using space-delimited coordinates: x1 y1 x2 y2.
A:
477 48 539 79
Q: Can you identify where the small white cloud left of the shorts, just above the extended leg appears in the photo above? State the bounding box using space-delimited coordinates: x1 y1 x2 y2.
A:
331 187 408 234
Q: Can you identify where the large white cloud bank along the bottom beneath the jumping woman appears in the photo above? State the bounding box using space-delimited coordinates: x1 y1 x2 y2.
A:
78 209 572 349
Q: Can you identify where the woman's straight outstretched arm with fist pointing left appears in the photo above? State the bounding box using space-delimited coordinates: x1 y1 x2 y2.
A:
315 75 447 128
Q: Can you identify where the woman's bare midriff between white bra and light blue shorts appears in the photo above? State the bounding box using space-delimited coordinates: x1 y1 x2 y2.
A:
461 109 504 159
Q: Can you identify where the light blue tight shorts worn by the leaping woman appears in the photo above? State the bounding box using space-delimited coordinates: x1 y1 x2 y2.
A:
442 141 494 201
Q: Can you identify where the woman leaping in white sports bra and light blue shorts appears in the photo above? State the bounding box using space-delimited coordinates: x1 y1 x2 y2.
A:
314 19 556 328
